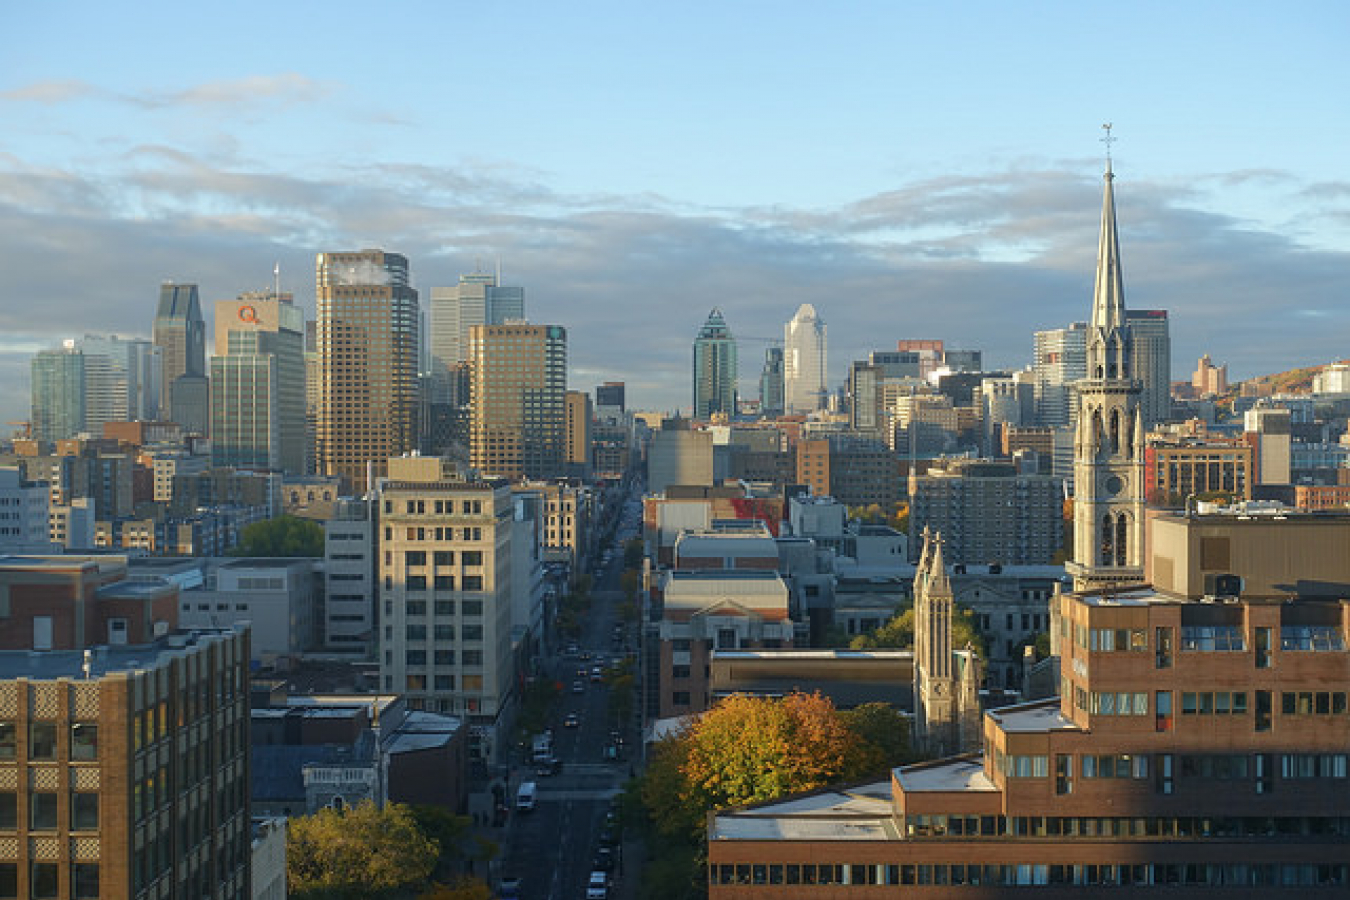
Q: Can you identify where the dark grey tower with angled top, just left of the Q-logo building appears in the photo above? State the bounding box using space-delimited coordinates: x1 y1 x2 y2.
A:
153 282 211 433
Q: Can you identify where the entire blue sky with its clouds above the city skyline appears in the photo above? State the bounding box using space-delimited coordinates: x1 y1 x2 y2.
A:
0 0 1350 421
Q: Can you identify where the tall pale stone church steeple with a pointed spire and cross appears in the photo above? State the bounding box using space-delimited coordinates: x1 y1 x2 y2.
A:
1067 157 1143 591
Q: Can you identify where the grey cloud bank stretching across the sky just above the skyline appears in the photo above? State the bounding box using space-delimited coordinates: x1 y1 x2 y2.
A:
0 149 1350 431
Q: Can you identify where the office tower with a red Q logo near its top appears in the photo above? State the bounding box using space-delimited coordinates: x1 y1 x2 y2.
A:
211 291 306 475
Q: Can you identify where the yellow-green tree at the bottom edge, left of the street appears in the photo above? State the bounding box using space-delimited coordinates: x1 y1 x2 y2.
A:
286 800 439 900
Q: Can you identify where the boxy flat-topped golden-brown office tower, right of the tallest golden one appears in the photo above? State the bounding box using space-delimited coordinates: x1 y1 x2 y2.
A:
468 322 567 480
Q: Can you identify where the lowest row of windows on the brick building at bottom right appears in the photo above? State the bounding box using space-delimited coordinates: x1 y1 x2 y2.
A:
707 862 1350 888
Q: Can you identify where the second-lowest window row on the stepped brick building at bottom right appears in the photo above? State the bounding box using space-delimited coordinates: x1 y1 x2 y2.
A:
903 814 1350 838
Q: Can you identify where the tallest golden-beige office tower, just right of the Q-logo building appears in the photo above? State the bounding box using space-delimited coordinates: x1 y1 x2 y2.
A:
315 250 419 491
